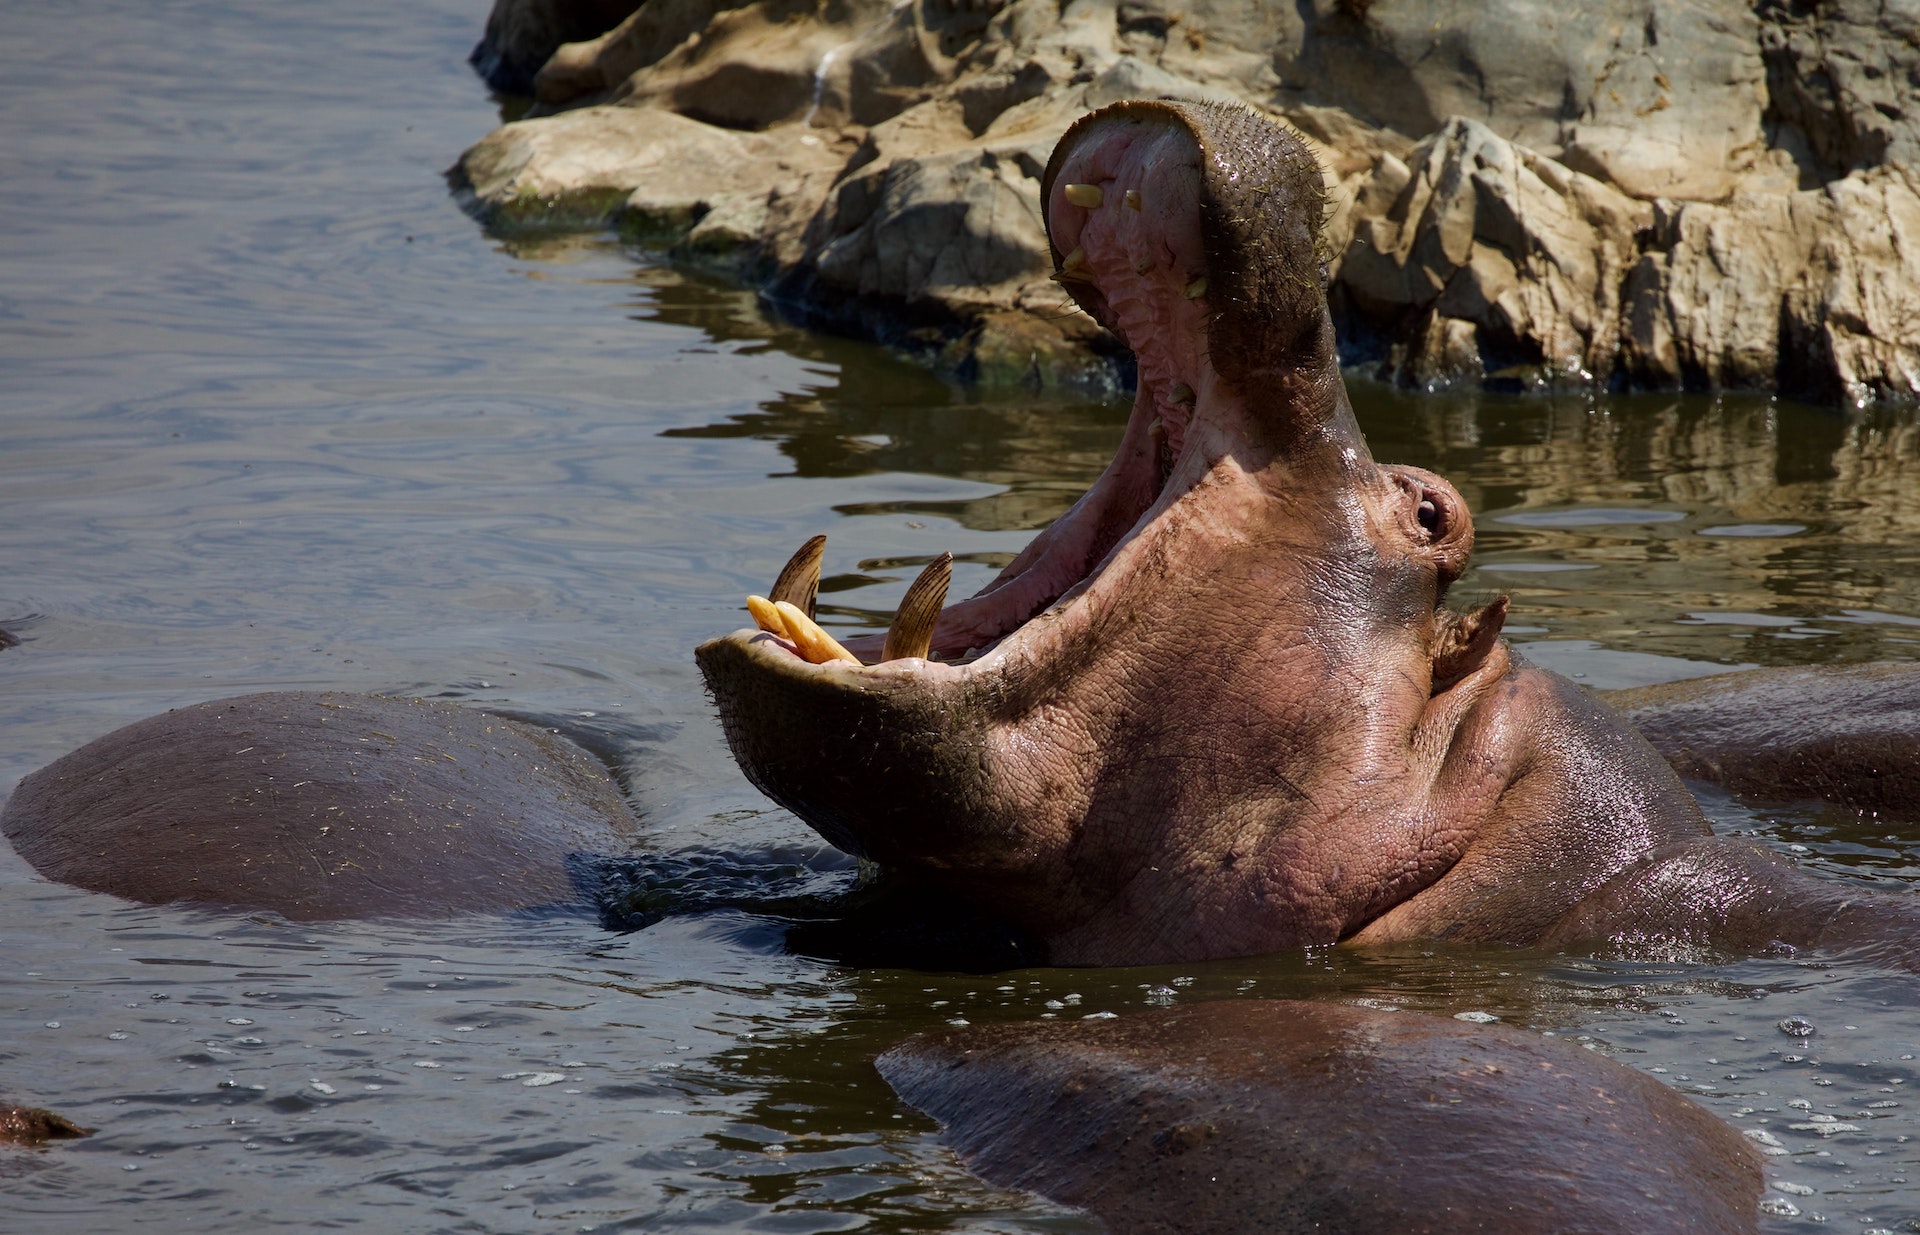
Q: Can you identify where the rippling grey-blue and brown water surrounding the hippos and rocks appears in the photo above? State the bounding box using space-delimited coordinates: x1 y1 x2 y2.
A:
11 0 1920 1233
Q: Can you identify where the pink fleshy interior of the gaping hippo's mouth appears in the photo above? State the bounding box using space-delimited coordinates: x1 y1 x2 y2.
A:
847 117 1213 659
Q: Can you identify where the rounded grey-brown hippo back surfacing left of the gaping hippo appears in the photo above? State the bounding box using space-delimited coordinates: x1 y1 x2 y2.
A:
0 691 634 918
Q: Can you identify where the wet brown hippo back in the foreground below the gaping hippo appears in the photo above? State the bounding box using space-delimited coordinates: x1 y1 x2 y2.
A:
876 1001 1761 1235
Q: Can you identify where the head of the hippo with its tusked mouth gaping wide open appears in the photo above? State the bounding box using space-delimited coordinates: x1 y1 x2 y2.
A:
697 102 1511 962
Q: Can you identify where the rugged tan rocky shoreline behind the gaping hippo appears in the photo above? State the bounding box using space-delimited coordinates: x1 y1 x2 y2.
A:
449 0 1920 405
